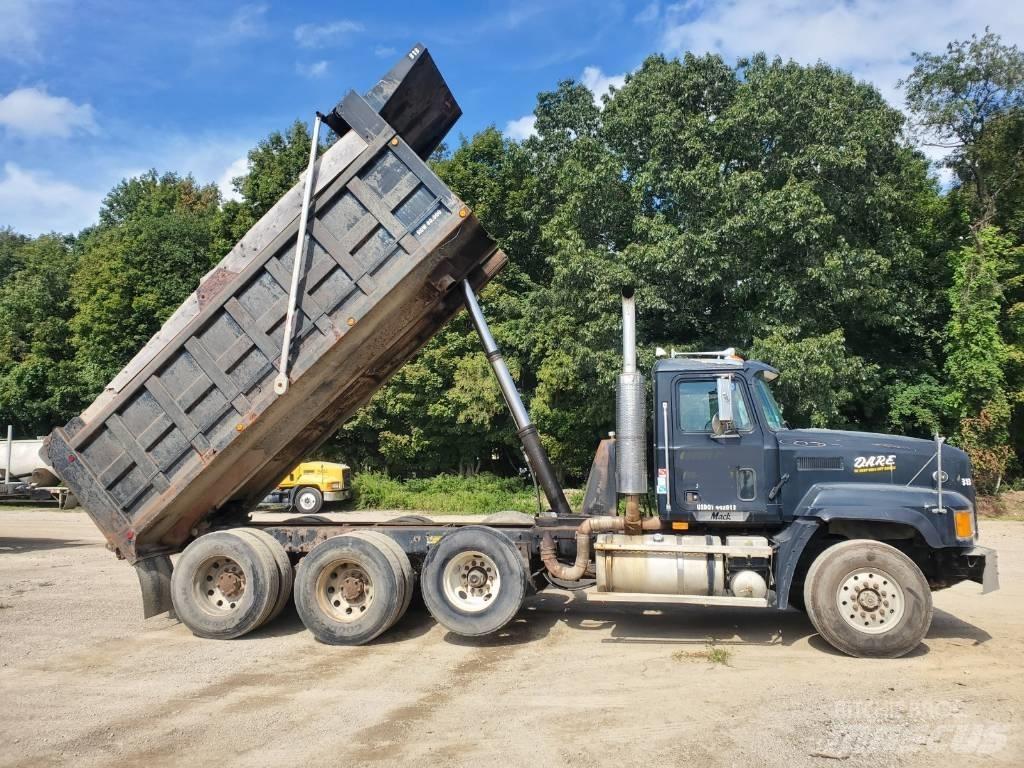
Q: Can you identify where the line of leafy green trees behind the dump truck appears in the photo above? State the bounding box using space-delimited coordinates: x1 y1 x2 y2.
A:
0 31 1024 490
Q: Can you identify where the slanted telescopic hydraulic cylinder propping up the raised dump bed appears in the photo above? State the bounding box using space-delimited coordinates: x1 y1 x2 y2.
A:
462 281 572 515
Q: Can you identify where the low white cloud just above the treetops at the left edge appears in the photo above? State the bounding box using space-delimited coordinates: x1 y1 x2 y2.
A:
0 162 105 234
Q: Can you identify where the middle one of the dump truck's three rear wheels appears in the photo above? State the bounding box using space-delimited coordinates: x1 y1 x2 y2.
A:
295 534 406 645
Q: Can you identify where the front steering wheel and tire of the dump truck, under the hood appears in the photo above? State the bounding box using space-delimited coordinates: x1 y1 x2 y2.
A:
804 539 932 658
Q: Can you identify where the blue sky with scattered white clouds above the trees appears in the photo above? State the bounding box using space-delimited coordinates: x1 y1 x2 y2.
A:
0 0 1024 233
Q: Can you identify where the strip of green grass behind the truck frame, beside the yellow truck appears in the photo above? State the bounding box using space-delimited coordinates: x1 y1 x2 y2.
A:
349 472 583 515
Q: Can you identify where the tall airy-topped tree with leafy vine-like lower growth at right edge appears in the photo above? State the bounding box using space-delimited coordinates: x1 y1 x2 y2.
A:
903 30 1024 489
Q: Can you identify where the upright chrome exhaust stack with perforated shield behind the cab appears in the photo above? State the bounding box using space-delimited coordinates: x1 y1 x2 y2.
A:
615 287 647 536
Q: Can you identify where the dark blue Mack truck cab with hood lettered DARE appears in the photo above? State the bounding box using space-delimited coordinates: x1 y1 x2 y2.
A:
651 349 995 607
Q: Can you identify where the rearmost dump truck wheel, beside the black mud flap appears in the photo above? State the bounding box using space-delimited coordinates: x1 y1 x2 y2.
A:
171 530 281 640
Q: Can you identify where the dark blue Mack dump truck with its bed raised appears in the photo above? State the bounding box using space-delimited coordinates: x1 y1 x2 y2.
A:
43 45 997 656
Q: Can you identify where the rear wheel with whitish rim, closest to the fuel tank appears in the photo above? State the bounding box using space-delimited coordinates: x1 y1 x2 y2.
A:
421 525 528 637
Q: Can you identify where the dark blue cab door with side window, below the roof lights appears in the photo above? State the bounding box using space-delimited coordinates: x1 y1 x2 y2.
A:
657 374 777 523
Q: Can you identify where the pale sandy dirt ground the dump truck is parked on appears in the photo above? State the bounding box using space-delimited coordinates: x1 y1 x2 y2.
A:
0 510 1024 768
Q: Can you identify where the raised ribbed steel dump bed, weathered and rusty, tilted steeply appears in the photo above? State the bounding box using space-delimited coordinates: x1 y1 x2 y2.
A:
43 49 505 562
